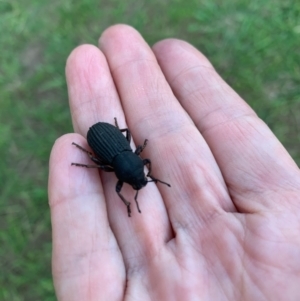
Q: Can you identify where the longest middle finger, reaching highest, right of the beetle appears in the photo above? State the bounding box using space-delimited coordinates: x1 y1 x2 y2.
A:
100 25 235 234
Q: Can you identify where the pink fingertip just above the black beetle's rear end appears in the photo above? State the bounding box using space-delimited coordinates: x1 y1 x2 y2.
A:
66 44 121 136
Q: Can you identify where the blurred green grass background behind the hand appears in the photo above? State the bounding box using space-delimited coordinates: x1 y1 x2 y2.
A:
0 0 300 301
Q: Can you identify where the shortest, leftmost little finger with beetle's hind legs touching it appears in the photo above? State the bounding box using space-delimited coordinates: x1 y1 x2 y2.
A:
48 134 125 301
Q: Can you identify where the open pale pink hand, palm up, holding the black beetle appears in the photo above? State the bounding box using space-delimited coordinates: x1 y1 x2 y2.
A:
49 25 300 301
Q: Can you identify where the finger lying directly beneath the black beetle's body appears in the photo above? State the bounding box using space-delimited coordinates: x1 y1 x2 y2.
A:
66 39 171 268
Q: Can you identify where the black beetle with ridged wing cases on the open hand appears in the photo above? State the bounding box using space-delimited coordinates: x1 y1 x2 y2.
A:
71 118 171 217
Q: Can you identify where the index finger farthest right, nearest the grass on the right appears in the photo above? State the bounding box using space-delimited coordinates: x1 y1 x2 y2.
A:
153 39 300 212
